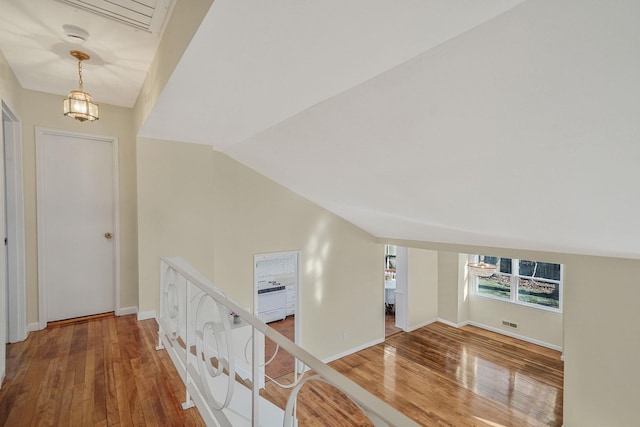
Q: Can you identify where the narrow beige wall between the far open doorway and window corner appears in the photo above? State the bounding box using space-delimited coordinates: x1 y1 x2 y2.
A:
407 248 438 330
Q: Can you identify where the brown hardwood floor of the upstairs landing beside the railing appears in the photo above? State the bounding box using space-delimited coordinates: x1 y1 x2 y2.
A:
0 315 204 426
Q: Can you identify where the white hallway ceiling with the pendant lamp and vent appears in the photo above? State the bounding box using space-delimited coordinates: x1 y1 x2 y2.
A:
0 0 172 107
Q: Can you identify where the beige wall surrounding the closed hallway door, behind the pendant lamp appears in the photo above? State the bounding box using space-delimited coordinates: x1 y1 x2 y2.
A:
21 90 138 323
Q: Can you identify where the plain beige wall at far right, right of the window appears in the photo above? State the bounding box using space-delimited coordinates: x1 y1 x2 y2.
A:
564 256 640 427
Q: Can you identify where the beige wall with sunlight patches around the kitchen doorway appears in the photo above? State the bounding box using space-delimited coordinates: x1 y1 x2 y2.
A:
214 153 384 358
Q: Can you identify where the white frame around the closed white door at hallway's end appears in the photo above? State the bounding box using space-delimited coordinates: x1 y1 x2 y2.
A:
36 126 120 329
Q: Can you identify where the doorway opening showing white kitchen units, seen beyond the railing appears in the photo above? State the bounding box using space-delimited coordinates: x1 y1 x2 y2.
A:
254 251 301 383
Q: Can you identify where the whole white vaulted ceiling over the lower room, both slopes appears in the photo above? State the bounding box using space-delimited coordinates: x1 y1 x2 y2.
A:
0 0 640 258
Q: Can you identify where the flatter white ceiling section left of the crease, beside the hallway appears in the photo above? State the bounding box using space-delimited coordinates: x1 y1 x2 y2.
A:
141 0 522 149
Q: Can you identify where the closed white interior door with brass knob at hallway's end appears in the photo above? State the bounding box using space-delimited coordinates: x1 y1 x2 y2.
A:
37 131 115 326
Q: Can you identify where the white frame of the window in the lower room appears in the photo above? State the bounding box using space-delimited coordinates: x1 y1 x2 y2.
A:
472 255 564 314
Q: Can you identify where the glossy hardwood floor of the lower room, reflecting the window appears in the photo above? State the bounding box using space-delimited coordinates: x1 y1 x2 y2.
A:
330 323 564 427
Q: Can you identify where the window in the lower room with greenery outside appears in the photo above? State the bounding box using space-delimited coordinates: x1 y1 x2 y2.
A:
473 255 562 312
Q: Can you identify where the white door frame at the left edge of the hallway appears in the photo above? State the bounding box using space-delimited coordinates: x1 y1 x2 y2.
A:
2 101 27 343
